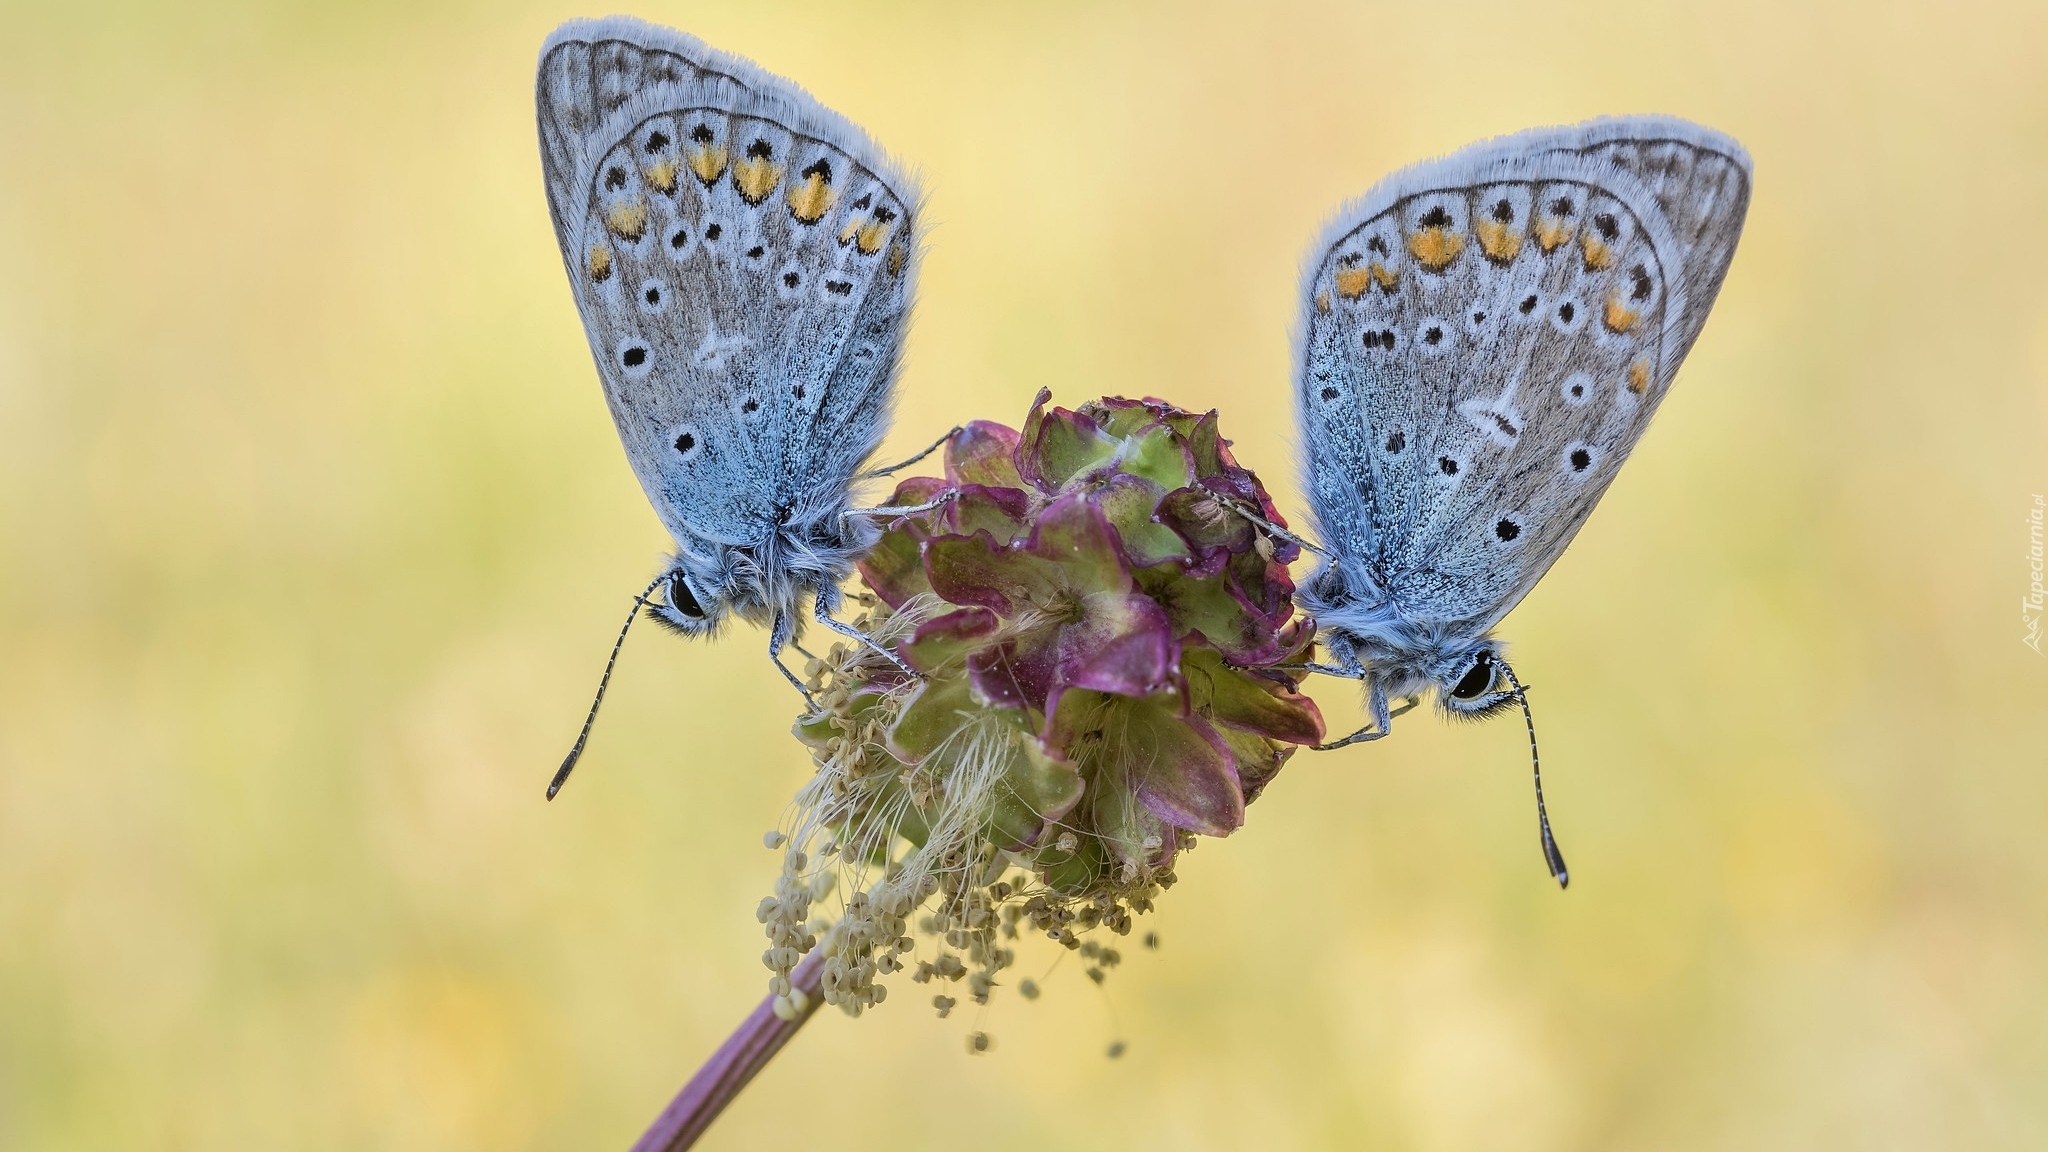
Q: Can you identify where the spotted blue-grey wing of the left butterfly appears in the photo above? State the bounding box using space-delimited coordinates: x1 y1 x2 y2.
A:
535 16 918 545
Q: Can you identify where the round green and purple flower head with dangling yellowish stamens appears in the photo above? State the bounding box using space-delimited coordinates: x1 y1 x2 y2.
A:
762 392 1323 1015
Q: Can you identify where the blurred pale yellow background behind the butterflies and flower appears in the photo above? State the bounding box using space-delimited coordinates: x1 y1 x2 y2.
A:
0 0 2048 1152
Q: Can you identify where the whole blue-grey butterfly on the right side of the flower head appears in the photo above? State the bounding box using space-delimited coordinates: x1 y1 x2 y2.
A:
1294 117 1751 883
